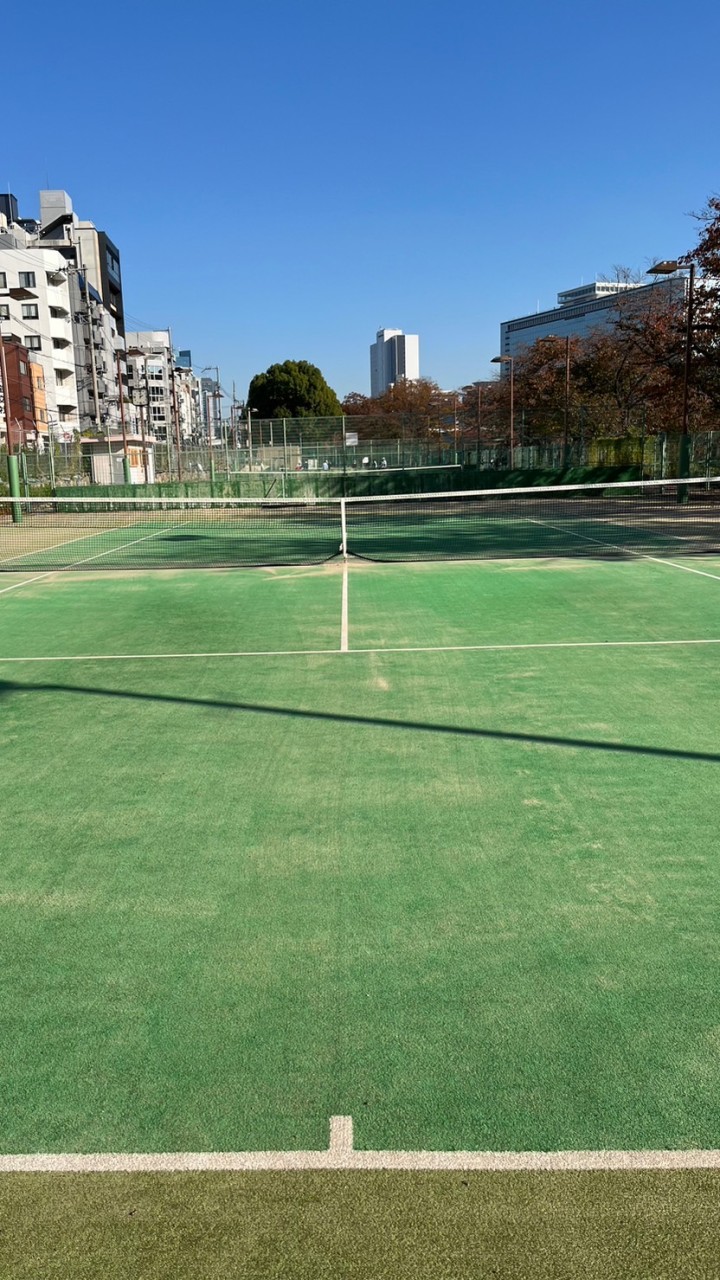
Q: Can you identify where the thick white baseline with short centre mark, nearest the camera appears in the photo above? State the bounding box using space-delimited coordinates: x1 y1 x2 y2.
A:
0 1116 720 1174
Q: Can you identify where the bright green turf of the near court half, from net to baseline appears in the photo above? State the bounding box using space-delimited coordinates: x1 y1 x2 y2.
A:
0 478 720 1269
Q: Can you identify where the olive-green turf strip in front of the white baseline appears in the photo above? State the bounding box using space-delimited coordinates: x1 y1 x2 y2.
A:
0 1171 717 1280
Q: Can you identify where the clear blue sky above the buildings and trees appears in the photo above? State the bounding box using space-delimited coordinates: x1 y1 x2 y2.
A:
0 0 720 398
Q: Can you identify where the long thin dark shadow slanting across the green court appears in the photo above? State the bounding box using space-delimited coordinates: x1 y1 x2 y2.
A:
0 680 720 764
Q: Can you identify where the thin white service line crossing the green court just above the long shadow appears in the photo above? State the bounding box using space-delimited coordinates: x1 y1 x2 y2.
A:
0 637 720 663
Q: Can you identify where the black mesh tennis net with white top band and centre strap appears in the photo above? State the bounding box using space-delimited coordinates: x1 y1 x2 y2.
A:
0 476 720 571
